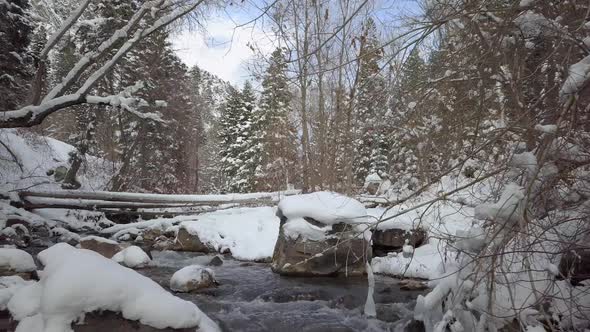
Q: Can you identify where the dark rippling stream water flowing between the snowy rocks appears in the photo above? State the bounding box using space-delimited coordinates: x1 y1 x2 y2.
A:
139 252 420 332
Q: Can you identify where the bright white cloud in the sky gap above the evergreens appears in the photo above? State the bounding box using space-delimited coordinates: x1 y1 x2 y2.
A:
171 17 274 84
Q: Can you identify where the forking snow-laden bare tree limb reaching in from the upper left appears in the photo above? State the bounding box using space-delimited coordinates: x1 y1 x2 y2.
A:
0 0 204 128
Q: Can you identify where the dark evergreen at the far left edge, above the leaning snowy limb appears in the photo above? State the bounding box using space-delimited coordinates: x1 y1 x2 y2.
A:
0 0 33 111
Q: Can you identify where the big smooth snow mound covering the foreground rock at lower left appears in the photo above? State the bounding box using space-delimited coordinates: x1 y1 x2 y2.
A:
8 243 219 332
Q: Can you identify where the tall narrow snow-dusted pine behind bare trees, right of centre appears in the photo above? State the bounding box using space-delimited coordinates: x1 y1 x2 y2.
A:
354 18 390 184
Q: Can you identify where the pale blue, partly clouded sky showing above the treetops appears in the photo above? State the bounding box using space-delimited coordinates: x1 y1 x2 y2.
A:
171 0 418 86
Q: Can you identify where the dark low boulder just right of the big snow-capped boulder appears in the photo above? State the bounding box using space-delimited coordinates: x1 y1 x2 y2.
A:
371 228 427 257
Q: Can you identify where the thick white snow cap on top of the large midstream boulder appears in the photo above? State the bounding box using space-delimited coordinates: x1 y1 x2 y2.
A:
278 191 367 225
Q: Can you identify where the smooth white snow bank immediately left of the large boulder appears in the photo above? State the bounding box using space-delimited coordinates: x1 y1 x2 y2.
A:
181 207 279 260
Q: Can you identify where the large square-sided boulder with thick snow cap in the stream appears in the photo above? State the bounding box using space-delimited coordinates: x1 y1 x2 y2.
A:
271 192 371 276
